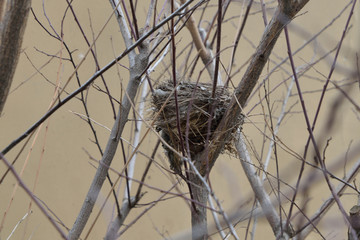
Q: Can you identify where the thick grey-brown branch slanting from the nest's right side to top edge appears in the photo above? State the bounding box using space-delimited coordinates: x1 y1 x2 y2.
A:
197 0 308 174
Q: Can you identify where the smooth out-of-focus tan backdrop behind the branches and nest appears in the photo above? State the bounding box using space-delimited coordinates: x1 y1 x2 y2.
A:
0 0 360 239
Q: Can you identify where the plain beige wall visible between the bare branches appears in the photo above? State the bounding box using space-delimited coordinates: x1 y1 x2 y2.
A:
0 0 360 239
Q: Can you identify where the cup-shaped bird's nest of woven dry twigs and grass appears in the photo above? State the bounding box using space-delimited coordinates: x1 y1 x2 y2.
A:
152 81 241 174
